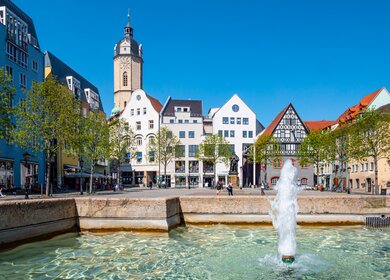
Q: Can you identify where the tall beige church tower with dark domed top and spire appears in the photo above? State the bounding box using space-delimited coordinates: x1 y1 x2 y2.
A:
113 13 143 113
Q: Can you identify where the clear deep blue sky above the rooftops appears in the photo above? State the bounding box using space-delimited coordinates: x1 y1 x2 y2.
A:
14 0 390 126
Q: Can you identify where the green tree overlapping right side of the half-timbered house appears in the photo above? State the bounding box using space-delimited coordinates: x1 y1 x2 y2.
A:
298 130 336 184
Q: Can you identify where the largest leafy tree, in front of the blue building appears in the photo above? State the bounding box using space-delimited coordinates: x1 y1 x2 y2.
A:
13 76 80 195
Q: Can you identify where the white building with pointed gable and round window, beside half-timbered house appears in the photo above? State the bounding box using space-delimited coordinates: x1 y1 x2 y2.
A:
206 94 264 186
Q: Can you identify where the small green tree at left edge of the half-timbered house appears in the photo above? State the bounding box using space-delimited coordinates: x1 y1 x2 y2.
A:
249 134 280 185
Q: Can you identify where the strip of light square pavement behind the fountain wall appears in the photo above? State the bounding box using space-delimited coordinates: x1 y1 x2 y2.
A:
0 187 378 202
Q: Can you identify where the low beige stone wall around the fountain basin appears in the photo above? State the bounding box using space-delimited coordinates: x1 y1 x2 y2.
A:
0 195 390 249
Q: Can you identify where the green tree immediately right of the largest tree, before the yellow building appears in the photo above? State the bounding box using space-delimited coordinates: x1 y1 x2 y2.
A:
79 111 110 193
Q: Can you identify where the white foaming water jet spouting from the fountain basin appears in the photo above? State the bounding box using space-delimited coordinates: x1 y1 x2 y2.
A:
270 160 298 263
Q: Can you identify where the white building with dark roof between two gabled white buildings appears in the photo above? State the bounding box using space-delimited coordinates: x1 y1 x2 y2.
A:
161 97 204 188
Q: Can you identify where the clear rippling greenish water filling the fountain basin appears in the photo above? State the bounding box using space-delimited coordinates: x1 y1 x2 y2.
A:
0 225 390 280
